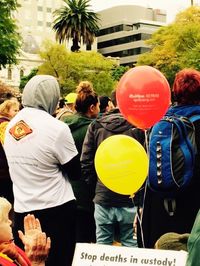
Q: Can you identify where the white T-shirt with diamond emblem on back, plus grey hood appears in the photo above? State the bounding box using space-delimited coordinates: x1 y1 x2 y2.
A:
4 75 77 213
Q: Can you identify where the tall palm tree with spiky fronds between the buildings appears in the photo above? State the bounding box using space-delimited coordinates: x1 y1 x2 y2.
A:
53 0 99 52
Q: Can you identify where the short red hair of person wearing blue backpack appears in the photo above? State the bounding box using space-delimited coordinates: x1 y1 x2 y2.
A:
173 69 200 104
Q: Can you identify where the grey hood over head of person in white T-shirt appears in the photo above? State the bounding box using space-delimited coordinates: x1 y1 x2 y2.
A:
22 75 60 115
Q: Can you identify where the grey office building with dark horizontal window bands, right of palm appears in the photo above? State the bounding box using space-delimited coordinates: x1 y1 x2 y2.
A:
97 5 166 66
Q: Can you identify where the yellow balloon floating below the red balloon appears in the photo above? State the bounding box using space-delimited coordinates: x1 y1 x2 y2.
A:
94 135 149 195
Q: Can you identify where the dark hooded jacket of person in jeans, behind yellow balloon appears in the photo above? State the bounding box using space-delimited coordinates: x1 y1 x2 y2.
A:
81 109 144 207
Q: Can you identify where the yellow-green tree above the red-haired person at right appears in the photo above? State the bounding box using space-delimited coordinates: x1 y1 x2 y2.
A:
137 6 200 85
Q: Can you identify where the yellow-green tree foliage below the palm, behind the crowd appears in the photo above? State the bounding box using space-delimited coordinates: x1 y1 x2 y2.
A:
38 41 116 95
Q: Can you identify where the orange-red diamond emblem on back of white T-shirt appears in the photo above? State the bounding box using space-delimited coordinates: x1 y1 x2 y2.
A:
9 120 33 140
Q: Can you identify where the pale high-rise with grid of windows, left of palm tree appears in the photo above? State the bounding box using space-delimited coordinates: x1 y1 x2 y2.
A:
15 0 63 53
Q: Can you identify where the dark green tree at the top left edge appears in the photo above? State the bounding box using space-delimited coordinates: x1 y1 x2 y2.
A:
0 0 21 67
